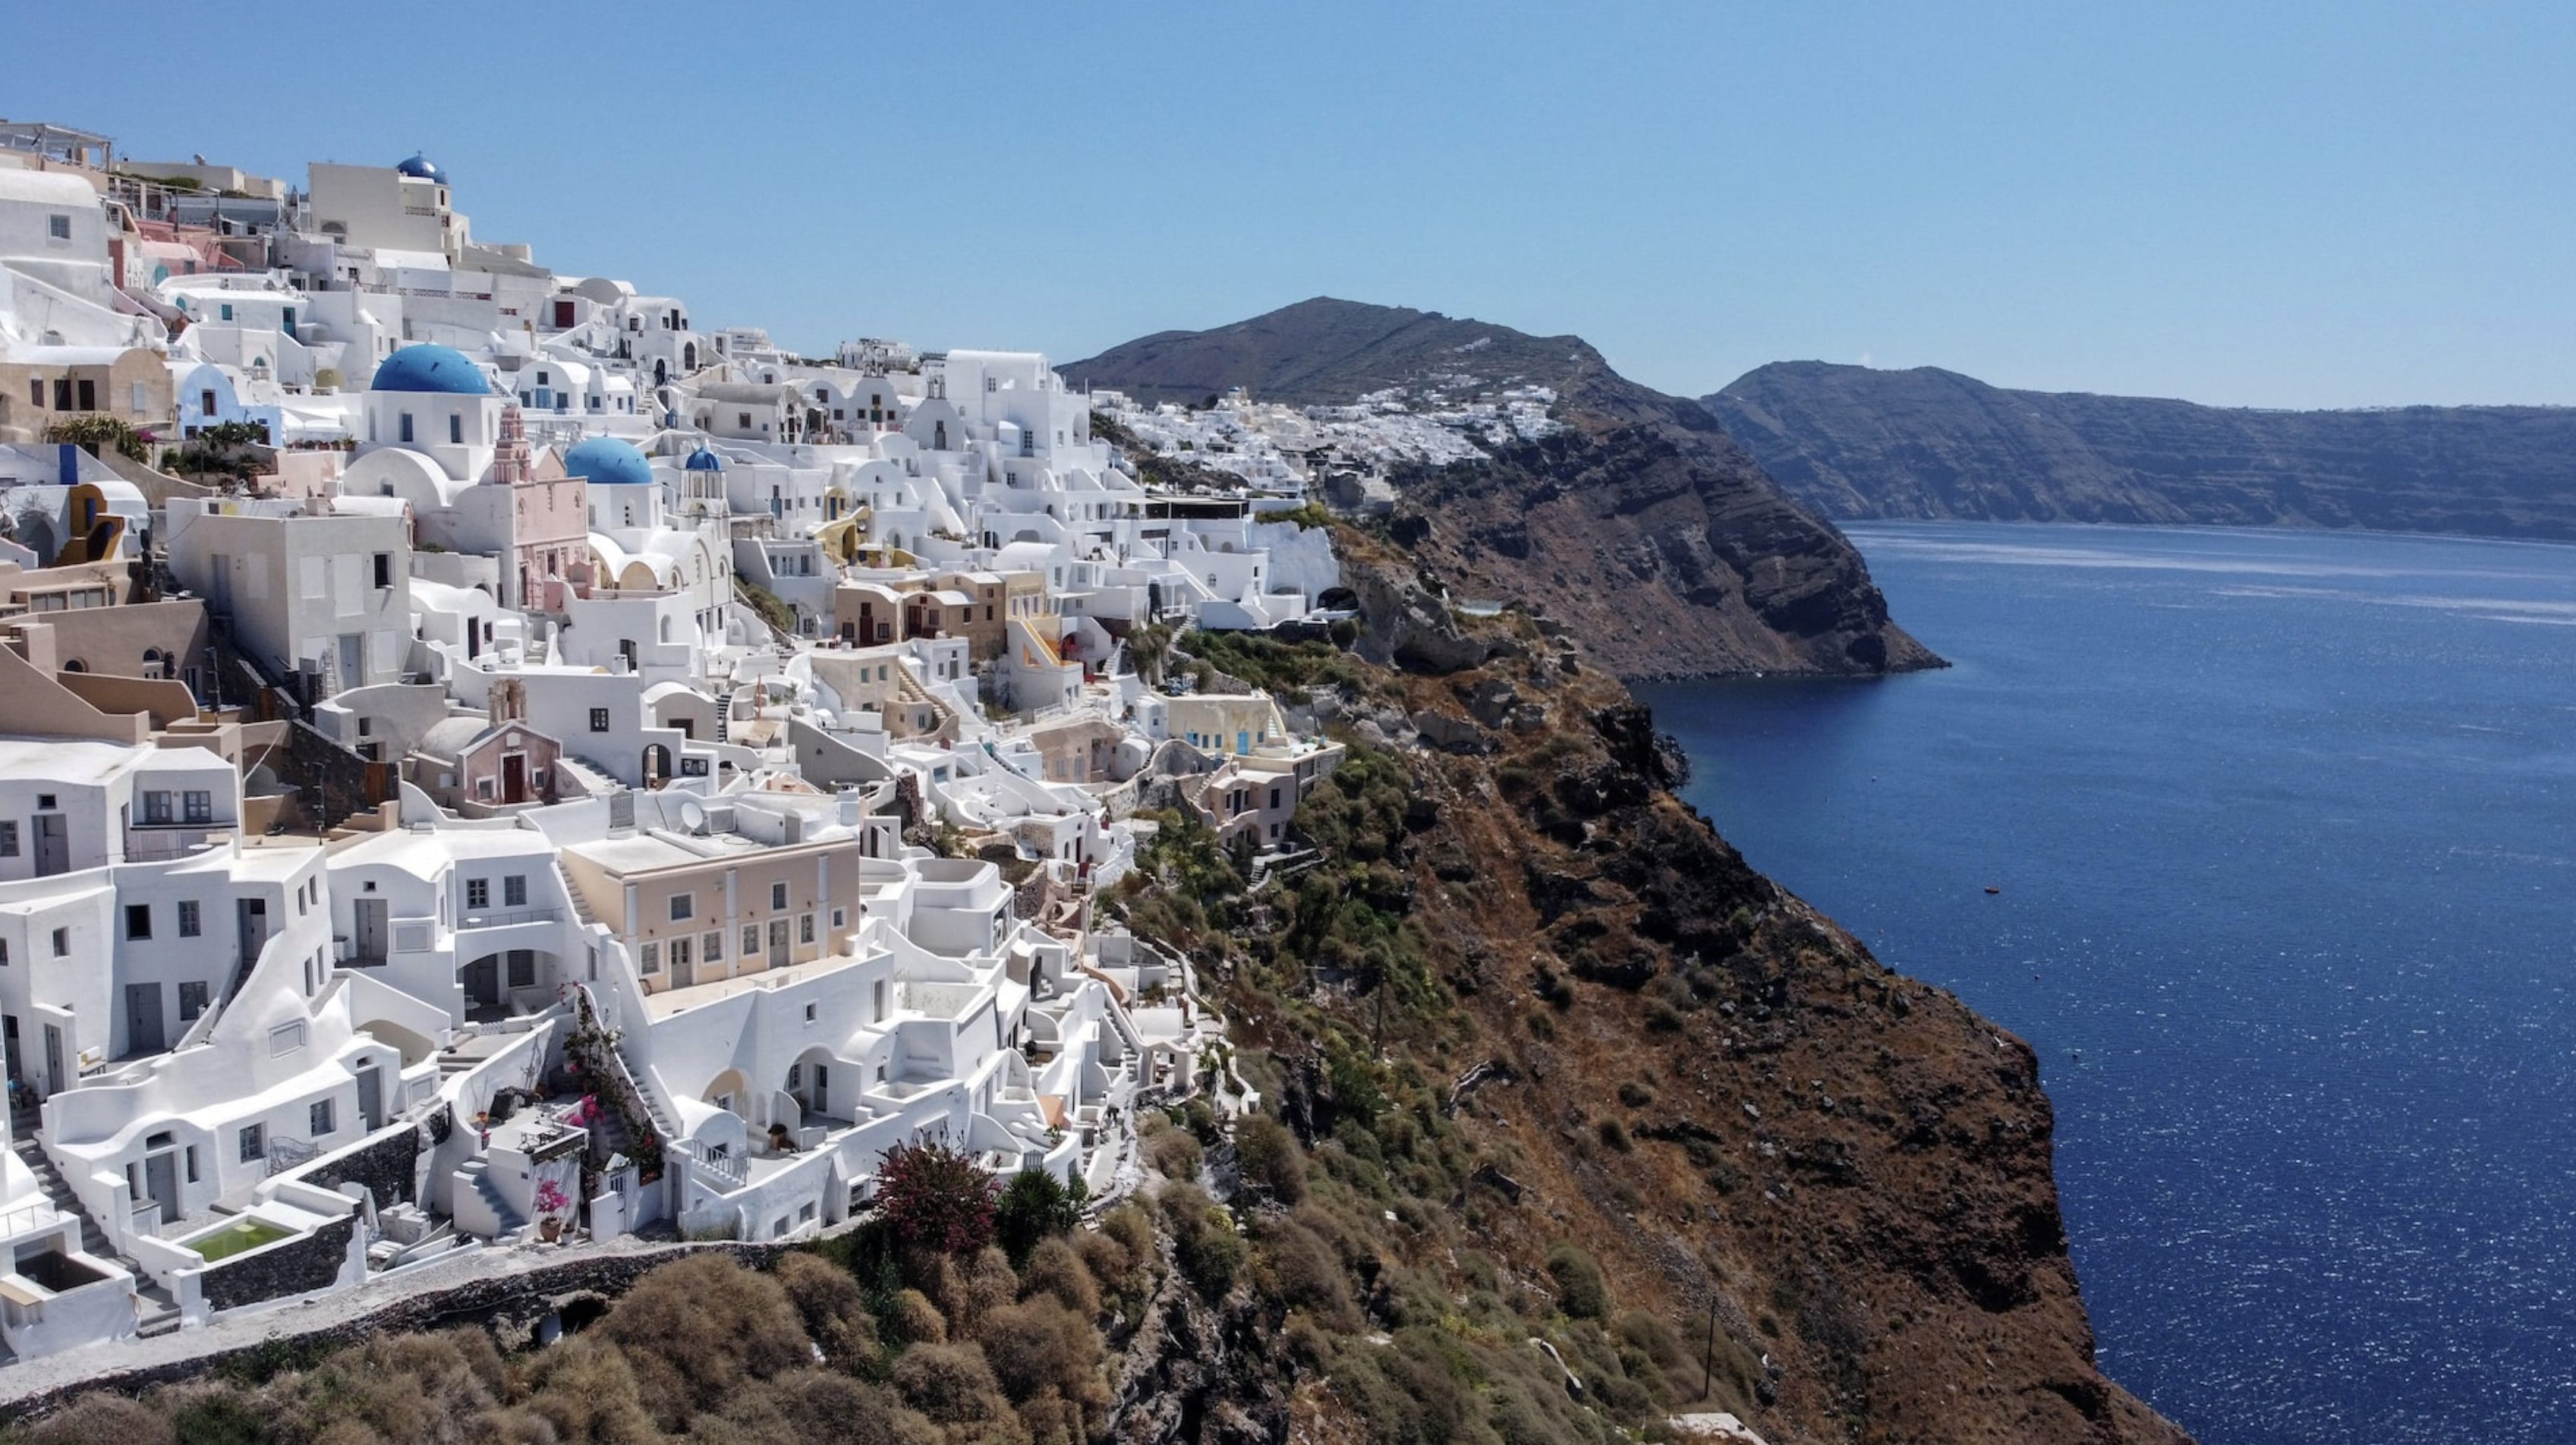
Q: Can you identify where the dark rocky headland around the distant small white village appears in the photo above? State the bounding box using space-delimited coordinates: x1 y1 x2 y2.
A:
1061 299 1940 678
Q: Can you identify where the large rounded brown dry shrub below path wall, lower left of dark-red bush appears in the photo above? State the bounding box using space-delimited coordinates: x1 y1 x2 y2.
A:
597 1255 814 1430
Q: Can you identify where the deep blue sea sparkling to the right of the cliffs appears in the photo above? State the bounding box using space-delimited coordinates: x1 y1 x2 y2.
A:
1641 523 2576 1445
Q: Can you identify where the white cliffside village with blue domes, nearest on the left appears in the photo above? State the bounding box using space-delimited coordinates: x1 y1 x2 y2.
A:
0 124 1390 1360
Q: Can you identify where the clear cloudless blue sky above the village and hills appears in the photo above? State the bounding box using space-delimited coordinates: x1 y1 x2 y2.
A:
0 0 2576 407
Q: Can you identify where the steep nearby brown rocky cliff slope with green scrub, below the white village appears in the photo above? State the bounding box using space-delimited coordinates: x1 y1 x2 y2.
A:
1102 543 2182 1445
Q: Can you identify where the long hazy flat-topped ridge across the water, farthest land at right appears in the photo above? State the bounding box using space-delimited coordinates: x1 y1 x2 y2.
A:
1700 360 2576 541
